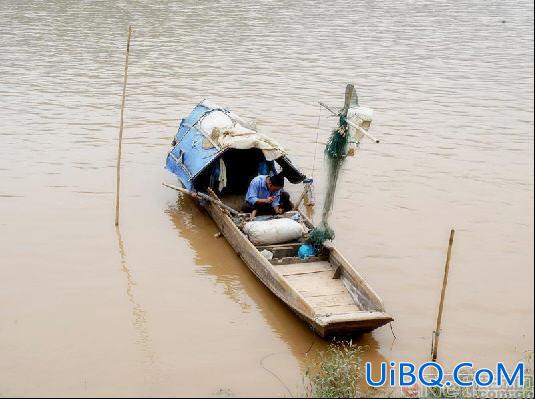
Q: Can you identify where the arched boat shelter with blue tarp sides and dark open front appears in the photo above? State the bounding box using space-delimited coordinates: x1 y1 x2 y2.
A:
166 100 306 196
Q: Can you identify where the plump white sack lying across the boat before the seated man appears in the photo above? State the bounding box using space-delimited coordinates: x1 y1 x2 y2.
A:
243 218 303 245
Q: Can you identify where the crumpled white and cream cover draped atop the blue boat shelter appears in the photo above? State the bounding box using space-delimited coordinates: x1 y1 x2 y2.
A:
200 103 286 161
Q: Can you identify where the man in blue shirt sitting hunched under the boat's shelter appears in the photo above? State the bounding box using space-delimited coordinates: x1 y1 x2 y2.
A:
243 174 292 215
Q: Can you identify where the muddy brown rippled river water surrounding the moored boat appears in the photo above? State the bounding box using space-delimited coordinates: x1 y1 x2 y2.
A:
0 0 534 396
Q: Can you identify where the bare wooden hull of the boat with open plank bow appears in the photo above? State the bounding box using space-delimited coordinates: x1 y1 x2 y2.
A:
204 203 393 337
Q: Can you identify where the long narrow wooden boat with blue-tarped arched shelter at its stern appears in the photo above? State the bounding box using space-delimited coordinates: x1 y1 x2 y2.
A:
166 101 393 337
